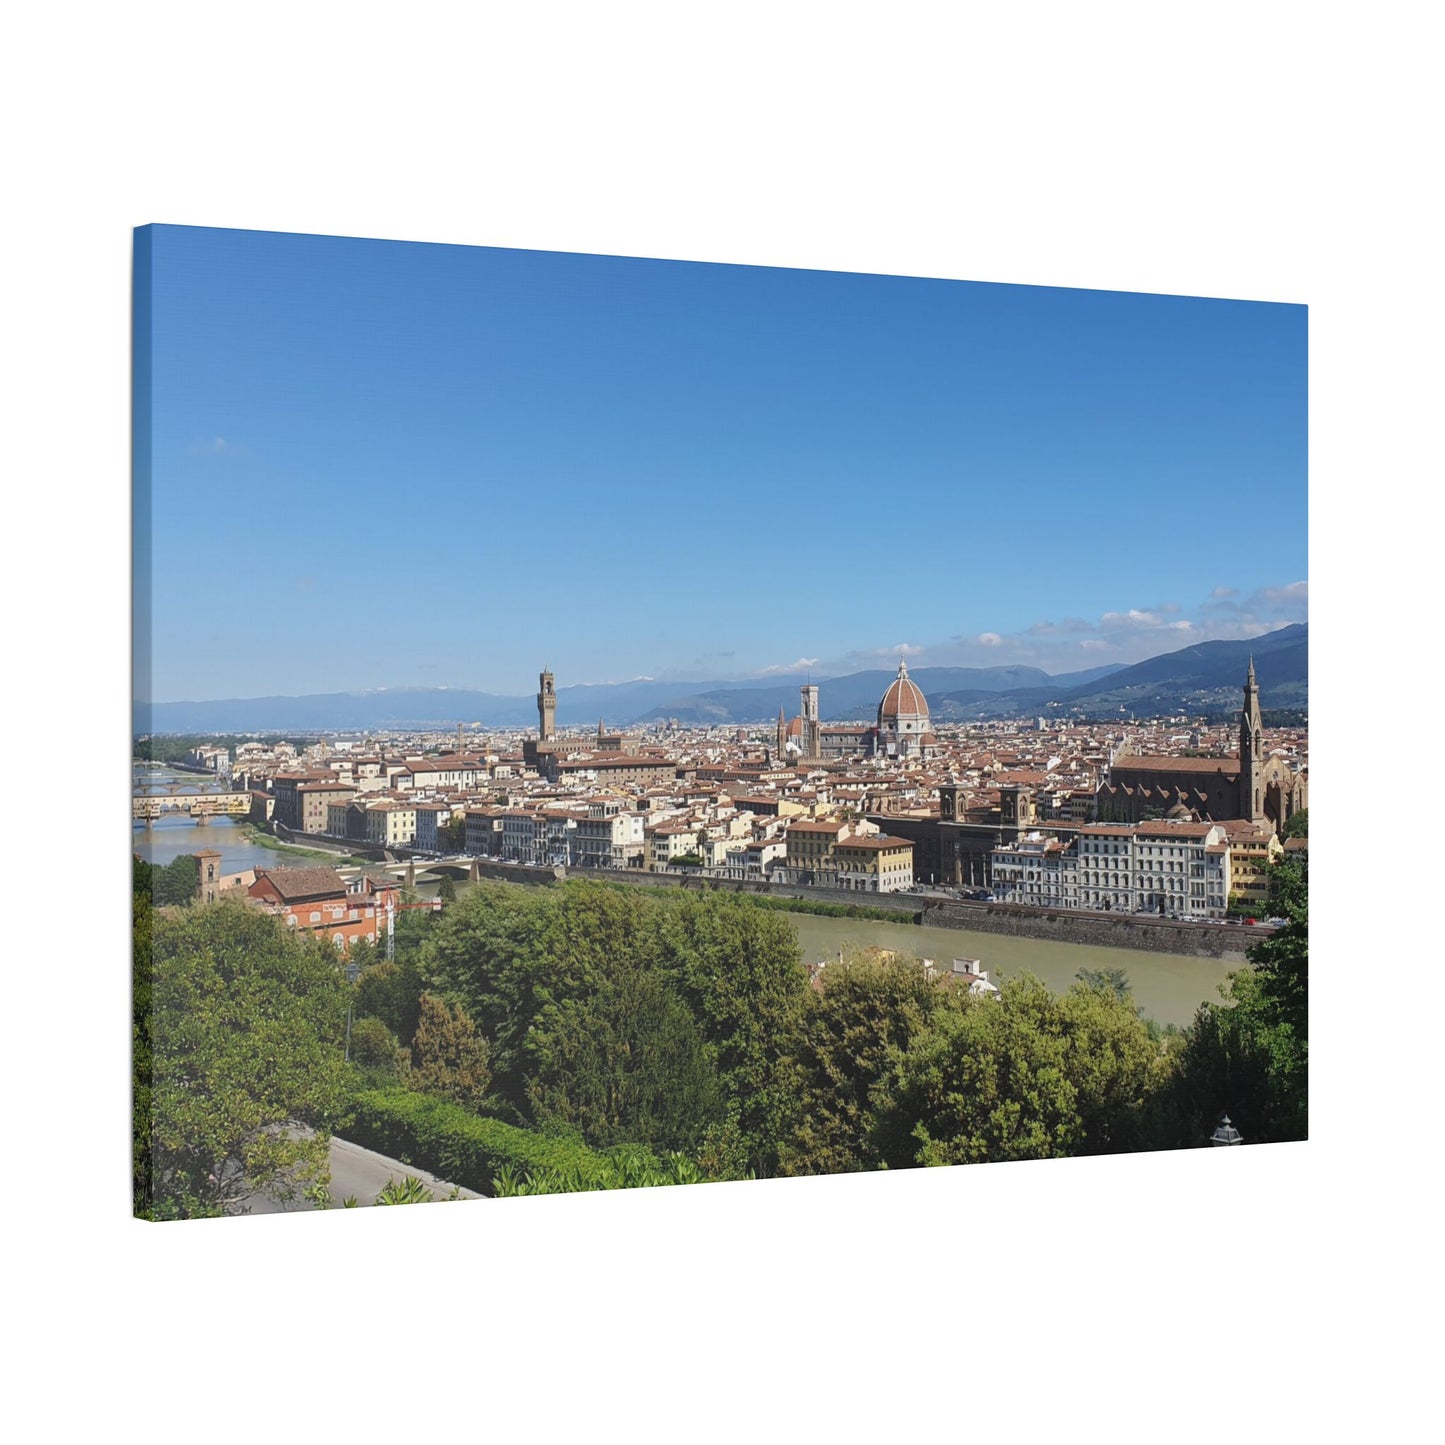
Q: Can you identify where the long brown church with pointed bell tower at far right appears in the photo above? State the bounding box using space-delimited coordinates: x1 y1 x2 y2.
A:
1094 659 1309 834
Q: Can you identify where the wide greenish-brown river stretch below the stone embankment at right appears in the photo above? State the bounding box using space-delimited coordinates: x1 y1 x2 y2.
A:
788 913 1240 1027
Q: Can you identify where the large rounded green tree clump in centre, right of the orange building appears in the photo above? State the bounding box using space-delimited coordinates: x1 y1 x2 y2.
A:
420 881 806 1173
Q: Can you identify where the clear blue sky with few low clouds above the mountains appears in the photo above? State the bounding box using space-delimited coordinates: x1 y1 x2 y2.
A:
136 227 1308 701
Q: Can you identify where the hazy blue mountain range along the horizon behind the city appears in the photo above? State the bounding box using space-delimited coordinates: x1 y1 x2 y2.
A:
133 623 1309 733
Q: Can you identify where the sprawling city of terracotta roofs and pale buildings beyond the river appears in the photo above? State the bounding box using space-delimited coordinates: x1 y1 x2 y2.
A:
143 647 1309 919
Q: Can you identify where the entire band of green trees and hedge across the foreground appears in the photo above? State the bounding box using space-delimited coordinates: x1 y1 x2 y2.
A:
133 860 1308 1218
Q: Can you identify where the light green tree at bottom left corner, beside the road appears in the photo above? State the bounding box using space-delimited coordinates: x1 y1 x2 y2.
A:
136 900 354 1220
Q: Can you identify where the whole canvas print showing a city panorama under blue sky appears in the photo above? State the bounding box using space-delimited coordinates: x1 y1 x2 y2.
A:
130 225 1309 1220
